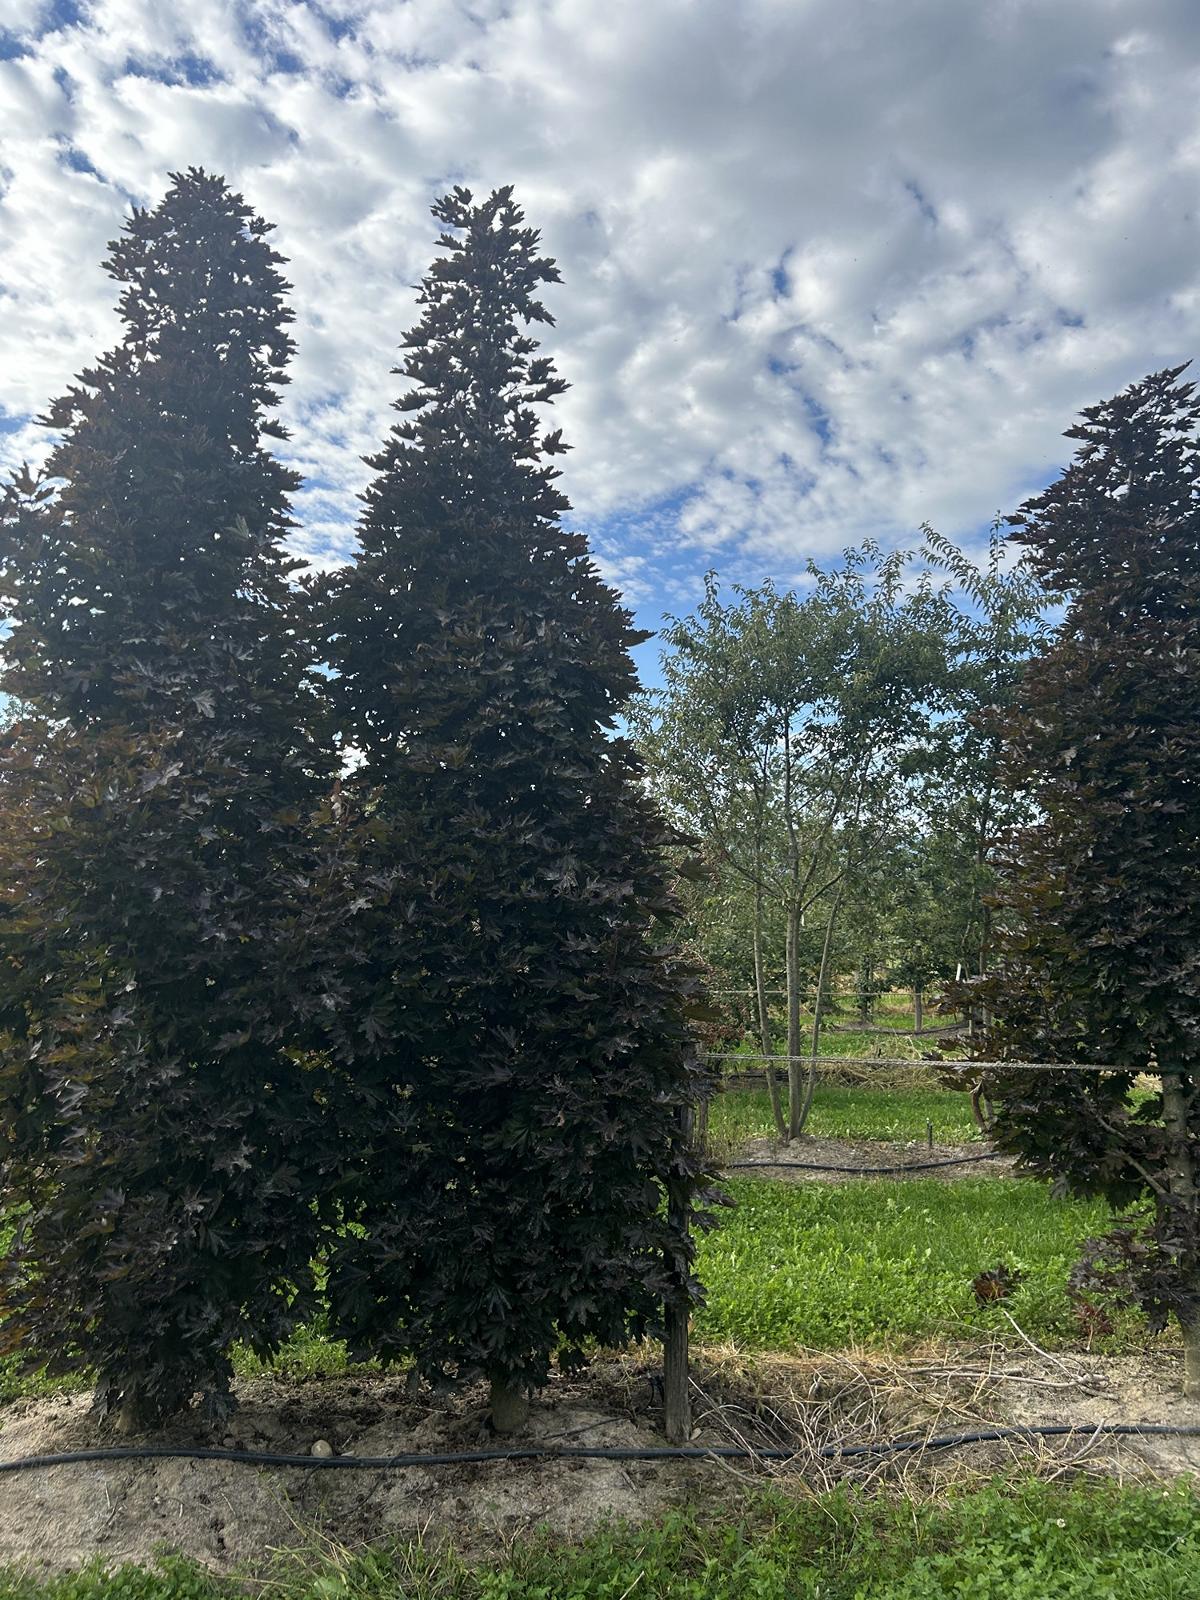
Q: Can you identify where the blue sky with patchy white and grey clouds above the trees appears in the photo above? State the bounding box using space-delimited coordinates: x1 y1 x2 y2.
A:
0 0 1200 665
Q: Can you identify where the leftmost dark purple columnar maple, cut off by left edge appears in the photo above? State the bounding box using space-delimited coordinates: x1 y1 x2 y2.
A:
0 170 336 1427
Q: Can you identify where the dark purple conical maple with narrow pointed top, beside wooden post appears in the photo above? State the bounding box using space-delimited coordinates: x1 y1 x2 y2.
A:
315 189 720 1429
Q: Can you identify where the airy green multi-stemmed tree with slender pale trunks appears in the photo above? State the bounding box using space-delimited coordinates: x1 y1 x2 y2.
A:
637 542 949 1139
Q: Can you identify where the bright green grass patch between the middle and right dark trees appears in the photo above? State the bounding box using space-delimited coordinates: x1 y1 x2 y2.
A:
696 1178 1142 1350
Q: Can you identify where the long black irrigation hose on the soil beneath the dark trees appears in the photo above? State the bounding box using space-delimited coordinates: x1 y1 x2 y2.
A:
0 1422 1200 1472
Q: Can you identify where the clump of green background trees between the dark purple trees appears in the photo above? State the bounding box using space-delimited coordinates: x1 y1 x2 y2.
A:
634 526 1053 1138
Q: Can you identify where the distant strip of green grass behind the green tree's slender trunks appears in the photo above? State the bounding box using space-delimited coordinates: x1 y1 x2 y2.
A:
709 1083 974 1144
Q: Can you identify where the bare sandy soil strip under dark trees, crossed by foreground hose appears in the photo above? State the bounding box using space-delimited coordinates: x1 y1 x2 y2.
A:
0 1338 1200 1571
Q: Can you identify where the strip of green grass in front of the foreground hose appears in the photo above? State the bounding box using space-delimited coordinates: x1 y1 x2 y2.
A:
0 1480 1200 1600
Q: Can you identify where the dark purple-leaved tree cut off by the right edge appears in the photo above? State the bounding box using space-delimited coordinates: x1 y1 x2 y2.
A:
981 368 1200 1397
